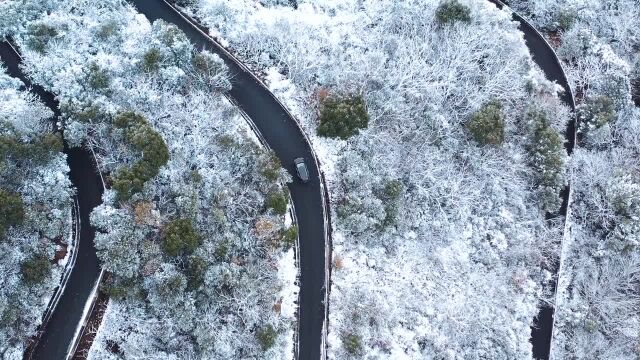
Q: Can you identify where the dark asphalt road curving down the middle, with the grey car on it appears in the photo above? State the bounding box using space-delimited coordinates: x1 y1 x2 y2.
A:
129 0 327 360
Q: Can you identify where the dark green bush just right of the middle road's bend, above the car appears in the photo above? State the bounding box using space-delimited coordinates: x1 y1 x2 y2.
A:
317 96 369 140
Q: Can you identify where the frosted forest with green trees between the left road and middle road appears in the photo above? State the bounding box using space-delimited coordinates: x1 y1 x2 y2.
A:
0 0 297 359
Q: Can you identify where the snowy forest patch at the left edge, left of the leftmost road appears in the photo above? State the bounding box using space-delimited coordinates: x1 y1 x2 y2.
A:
0 66 73 359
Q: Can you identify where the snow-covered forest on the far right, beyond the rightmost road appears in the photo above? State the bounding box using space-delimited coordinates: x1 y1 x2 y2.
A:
510 0 640 359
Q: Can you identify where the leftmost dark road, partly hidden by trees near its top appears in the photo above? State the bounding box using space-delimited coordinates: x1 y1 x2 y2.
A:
0 42 103 360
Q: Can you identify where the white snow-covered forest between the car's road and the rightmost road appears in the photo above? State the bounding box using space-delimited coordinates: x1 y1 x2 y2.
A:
182 0 569 359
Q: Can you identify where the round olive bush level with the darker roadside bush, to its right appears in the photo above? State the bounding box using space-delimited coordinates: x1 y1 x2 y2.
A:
466 100 504 146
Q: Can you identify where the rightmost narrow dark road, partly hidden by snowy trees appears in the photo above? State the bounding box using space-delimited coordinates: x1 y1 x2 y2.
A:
488 0 576 359
